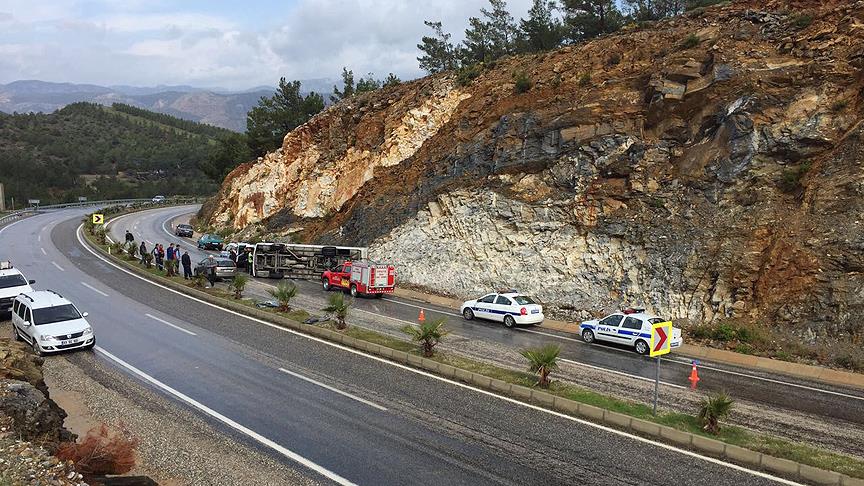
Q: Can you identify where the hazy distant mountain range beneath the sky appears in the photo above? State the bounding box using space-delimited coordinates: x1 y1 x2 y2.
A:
0 79 332 132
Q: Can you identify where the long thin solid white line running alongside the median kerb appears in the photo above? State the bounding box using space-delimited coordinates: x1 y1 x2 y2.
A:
77 224 804 486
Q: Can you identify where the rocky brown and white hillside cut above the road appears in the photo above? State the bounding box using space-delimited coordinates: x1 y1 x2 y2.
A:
202 0 864 339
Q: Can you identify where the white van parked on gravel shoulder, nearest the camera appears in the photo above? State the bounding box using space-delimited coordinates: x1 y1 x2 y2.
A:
12 290 96 356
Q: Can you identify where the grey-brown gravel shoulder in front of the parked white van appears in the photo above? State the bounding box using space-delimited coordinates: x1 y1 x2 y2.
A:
43 353 319 486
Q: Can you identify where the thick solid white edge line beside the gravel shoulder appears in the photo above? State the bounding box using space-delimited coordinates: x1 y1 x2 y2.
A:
96 346 356 486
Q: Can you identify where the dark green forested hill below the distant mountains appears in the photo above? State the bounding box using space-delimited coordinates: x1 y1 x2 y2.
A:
0 103 223 206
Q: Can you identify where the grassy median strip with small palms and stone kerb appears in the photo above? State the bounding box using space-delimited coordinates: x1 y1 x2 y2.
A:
79 213 864 486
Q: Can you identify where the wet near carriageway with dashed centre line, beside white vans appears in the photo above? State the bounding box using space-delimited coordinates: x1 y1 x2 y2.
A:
0 210 808 485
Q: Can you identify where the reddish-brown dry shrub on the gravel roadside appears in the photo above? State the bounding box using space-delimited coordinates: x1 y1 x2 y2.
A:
55 424 138 476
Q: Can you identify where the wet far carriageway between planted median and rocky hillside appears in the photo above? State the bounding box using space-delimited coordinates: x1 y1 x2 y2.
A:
126 206 864 424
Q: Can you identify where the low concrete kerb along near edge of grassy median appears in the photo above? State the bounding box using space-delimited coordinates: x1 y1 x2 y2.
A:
91 226 864 486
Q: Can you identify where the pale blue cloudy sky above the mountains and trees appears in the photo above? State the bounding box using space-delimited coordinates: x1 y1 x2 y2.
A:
0 0 531 90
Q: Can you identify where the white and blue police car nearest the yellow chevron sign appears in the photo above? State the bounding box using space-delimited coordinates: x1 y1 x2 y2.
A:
579 308 684 354
